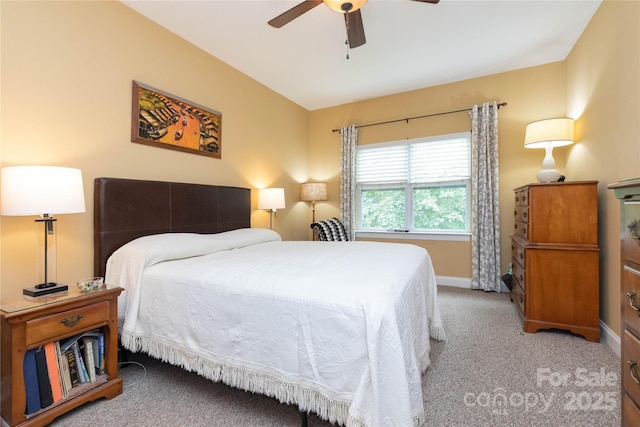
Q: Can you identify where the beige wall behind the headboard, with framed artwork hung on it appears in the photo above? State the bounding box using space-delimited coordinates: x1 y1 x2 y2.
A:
0 1 309 296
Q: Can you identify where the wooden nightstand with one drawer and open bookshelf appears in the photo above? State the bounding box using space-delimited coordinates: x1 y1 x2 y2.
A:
0 286 123 427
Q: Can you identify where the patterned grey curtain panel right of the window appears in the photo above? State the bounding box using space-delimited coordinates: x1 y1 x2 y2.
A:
469 102 501 292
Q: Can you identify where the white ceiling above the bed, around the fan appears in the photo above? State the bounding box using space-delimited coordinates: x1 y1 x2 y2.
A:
121 0 601 110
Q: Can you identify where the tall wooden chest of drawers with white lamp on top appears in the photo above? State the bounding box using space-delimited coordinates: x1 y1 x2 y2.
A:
511 181 600 342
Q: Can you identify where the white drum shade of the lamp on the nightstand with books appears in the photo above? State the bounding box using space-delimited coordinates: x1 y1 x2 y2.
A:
0 166 86 216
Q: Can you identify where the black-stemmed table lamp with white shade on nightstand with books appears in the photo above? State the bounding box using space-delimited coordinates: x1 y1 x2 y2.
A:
0 166 86 297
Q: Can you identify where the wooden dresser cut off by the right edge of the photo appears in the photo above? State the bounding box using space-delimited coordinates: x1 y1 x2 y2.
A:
607 179 640 426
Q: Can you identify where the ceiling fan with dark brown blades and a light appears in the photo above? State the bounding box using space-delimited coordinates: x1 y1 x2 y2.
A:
269 0 440 49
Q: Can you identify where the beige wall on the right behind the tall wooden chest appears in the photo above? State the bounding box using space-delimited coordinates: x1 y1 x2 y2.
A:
566 0 640 336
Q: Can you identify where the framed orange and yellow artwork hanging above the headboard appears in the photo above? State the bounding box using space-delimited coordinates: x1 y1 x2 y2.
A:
131 80 222 159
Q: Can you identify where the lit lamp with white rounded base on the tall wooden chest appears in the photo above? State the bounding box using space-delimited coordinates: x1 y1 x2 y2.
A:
524 117 574 183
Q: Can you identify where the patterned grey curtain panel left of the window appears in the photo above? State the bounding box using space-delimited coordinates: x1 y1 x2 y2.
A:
340 125 358 240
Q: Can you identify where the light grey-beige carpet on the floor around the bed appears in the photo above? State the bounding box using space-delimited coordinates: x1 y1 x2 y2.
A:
52 287 620 427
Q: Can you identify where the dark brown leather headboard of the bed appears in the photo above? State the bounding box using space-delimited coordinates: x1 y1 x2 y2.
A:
93 178 251 277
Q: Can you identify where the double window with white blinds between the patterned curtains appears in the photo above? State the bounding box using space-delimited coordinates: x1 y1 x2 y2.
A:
356 132 471 233
